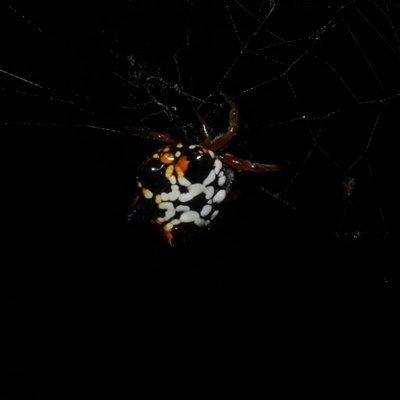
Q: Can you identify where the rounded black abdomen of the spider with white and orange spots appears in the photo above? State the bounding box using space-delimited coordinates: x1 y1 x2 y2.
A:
135 143 234 246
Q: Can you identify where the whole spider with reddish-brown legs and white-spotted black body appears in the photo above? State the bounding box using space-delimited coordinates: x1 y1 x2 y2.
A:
128 91 283 247
